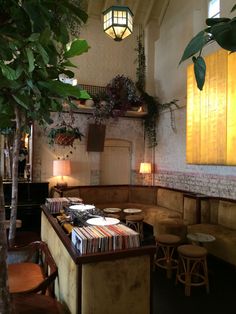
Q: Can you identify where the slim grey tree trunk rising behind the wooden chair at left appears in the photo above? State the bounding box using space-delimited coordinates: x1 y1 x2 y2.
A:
8 106 21 246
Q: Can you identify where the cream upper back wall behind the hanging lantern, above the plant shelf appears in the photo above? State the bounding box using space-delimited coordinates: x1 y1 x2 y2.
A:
73 17 137 86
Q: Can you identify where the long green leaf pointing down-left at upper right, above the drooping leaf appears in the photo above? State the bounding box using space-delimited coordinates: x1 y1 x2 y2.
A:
179 30 211 64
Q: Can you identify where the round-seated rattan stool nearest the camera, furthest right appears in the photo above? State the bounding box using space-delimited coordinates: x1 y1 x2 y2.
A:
176 244 209 296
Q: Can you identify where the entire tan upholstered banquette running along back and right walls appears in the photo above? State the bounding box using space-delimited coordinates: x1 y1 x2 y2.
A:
51 185 236 265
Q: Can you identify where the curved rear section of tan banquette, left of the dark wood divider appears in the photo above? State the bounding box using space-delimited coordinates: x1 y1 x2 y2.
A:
51 185 196 235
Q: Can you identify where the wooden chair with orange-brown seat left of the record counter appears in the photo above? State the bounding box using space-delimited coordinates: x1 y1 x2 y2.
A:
8 241 58 296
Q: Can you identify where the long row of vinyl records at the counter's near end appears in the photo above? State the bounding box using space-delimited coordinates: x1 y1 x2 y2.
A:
71 224 140 254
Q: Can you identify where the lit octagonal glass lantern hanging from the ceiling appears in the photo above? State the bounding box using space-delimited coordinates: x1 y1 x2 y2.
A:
103 6 133 41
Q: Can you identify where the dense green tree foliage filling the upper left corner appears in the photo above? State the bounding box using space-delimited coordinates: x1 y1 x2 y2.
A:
0 0 89 132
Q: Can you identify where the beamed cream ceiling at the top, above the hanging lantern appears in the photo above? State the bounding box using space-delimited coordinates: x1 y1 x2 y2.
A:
86 0 170 27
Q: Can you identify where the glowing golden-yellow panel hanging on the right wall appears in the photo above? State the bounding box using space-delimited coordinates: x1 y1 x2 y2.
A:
186 49 236 165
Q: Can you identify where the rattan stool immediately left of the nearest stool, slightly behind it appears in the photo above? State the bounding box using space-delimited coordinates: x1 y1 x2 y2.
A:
155 233 181 278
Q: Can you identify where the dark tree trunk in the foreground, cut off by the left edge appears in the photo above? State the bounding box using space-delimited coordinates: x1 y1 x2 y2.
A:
0 177 12 314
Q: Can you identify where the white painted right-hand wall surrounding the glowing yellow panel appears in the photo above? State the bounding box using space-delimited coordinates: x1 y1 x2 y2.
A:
155 0 236 198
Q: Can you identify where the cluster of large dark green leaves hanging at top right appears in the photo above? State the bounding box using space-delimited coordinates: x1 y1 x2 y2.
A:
180 4 236 90
